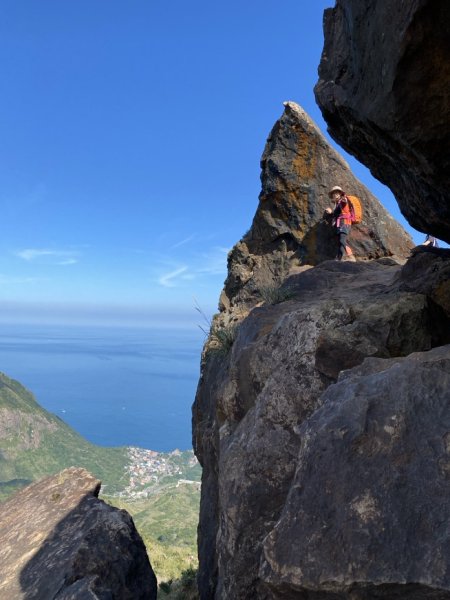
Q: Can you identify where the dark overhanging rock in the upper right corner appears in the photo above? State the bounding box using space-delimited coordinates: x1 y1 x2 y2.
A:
315 0 450 242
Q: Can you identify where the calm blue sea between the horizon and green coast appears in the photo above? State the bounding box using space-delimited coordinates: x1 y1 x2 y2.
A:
0 325 203 452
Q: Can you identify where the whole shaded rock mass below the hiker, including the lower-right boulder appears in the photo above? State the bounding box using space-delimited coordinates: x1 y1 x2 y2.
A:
194 250 450 600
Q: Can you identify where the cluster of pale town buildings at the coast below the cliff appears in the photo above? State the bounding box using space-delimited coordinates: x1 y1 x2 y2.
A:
117 447 201 499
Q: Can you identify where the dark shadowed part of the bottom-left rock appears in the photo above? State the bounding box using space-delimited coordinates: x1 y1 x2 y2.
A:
20 496 157 600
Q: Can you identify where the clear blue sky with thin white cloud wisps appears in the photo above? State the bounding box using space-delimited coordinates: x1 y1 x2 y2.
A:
0 0 423 322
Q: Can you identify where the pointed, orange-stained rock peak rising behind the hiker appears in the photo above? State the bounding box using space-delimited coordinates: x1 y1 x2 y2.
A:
220 102 413 317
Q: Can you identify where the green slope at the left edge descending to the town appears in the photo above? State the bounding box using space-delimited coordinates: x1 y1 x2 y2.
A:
0 373 129 501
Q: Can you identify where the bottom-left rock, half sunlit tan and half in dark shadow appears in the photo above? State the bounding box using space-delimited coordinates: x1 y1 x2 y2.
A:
0 468 157 600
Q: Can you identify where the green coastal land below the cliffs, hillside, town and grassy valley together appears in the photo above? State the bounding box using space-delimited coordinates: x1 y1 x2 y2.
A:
0 373 201 581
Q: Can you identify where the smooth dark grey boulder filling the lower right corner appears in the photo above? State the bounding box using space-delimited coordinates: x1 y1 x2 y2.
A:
261 346 450 600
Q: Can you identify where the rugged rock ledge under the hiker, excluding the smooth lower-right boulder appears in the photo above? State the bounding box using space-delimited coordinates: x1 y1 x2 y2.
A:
194 251 450 600
